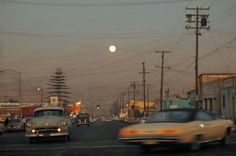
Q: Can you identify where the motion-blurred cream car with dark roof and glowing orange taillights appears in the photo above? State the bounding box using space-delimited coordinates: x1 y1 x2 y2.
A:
119 109 233 151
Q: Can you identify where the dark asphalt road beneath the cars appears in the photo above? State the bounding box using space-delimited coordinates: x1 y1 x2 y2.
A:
0 121 236 156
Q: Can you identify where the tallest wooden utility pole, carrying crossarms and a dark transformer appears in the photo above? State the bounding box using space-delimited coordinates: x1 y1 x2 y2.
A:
185 7 210 108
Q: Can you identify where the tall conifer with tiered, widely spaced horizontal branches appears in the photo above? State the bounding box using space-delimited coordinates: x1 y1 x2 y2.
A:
48 68 71 105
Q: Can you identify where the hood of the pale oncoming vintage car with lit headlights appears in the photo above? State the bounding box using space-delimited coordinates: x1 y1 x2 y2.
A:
31 116 64 127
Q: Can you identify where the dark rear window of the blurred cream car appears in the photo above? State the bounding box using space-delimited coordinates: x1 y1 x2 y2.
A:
146 111 191 123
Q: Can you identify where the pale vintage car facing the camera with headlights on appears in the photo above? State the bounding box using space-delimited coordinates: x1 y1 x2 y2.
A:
25 106 71 143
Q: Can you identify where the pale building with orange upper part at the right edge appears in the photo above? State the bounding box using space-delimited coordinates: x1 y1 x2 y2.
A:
199 73 236 121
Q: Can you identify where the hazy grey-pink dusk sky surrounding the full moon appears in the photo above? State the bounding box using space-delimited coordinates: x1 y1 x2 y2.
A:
0 0 236 105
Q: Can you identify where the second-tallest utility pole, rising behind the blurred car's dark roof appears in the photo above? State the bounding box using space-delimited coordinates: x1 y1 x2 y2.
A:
156 50 171 111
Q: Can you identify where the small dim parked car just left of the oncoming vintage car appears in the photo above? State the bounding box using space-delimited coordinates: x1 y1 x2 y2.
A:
7 119 25 131
